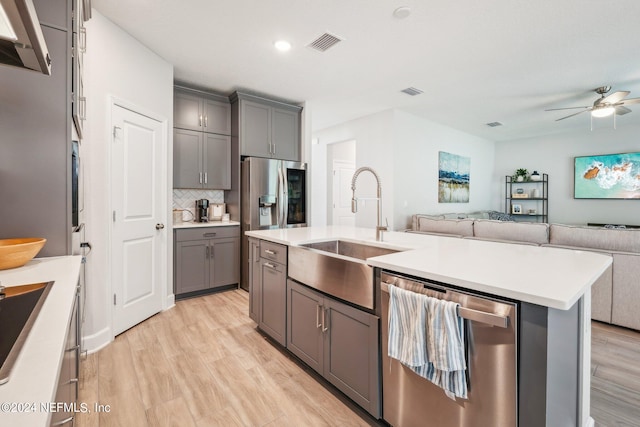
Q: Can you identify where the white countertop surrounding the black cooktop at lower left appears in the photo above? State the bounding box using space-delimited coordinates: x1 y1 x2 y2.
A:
0 256 82 427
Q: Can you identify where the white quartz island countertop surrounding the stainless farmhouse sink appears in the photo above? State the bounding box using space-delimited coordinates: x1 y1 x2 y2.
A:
246 226 612 310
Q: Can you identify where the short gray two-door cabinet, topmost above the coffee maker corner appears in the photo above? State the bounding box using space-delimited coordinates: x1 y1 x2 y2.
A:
173 88 231 135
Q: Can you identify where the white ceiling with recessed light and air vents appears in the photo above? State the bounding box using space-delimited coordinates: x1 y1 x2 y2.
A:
89 0 640 141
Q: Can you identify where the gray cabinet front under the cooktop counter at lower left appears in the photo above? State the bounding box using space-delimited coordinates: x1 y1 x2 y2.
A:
50 293 80 427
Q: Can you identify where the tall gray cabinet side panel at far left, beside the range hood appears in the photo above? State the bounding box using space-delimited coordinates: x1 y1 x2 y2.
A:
0 0 72 257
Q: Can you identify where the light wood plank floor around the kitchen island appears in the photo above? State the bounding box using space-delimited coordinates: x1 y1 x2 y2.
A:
77 290 640 427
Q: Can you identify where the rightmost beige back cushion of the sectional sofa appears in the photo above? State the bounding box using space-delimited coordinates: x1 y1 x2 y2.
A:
549 224 640 252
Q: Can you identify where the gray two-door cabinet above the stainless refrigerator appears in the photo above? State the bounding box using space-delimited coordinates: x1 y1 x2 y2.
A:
231 92 302 161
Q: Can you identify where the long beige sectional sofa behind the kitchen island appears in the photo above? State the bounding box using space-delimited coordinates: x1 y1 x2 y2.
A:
407 214 640 330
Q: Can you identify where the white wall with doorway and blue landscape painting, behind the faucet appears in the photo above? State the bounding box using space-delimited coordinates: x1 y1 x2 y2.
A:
312 110 500 230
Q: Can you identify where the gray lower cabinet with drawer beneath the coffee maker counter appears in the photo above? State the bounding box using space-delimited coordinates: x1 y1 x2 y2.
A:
174 226 240 296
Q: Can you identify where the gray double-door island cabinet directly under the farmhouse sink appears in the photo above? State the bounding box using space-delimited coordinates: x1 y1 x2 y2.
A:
286 279 381 417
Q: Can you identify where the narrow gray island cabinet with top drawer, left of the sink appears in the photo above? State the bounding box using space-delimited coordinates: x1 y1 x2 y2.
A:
254 240 287 346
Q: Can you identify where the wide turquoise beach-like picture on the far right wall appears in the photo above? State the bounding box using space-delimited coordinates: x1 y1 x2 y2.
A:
574 153 640 199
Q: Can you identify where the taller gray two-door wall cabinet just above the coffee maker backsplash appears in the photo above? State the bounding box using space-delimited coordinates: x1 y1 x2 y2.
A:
173 128 231 190
